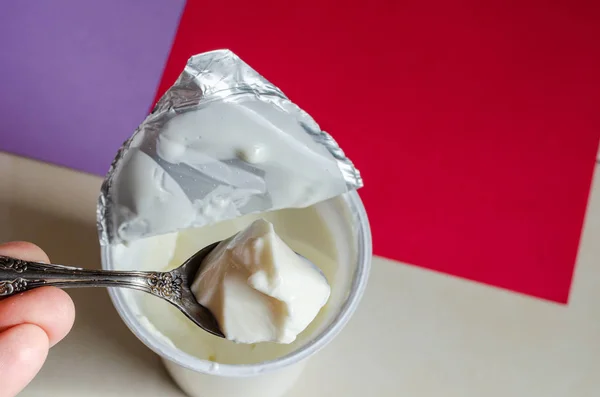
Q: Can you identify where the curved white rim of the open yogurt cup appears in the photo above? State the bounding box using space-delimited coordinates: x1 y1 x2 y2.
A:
101 191 373 377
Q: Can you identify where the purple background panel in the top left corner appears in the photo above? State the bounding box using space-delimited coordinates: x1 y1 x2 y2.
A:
0 0 185 175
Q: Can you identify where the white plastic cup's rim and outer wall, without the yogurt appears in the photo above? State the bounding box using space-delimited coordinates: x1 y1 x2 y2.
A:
102 192 372 397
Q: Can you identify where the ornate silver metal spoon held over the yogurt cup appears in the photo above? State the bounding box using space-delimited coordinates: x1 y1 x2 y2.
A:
0 242 225 338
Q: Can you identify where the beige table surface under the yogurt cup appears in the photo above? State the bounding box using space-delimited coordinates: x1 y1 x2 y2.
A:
0 153 600 397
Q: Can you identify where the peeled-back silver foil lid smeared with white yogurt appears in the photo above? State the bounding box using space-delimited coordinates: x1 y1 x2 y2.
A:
97 50 362 245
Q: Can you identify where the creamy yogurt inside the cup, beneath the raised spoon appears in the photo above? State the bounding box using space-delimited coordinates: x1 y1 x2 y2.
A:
111 199 354 364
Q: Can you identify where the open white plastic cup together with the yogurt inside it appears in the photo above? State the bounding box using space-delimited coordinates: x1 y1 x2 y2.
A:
102 192 371 397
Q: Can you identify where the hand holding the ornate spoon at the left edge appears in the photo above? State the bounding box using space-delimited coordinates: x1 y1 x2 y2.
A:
0 242 75 397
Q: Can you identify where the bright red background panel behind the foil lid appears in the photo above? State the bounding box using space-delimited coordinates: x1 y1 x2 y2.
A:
159 0 600 302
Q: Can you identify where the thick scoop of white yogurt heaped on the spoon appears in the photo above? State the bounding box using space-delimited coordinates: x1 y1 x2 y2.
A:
191 219 330 344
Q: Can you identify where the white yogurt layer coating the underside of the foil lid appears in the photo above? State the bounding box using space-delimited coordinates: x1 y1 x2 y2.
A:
105 95 348 241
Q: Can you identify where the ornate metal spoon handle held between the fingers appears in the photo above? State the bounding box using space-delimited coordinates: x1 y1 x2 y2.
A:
0 255 182 300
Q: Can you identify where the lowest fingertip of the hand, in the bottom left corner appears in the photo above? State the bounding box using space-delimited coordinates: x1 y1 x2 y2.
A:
0 324 49 397
